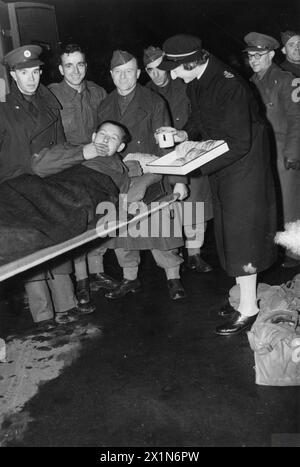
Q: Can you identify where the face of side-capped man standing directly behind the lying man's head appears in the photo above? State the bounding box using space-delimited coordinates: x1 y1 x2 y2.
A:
110 58 141 96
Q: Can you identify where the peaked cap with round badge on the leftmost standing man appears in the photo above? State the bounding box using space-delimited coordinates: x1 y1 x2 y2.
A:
3 44 44 70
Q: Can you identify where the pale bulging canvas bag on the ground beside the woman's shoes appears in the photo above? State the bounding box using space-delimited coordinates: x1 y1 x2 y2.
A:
247 309 300 386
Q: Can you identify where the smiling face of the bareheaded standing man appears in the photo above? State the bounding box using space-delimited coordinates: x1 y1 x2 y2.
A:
59 52 87 88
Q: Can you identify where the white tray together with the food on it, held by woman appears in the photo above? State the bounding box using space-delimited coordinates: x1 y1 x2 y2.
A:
147 140 229 175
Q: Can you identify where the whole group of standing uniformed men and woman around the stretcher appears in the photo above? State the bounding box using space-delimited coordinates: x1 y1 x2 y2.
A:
0 26 300 335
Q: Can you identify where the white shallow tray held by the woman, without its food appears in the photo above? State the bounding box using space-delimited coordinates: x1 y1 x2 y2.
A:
147 140 229 175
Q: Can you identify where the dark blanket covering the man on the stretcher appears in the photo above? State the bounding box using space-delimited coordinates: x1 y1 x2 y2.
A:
0 165 118 265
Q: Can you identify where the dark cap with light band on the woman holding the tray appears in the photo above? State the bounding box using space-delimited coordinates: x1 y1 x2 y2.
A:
159 34 202 70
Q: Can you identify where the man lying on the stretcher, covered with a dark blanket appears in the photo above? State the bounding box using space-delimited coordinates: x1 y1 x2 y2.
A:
0 121 178 265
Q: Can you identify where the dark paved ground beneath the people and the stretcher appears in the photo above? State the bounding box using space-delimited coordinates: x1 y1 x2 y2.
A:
0 224 300 448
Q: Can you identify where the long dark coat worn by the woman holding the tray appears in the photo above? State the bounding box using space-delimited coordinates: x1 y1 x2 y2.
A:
185 56 276 277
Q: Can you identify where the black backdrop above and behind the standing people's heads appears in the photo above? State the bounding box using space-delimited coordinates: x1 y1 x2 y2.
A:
2 0 300 90
